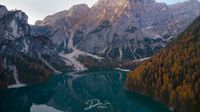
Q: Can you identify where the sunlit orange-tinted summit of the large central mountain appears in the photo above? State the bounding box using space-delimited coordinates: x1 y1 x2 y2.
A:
90 0 162 23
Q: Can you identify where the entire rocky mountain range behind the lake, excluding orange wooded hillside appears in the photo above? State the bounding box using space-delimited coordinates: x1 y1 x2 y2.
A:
0 0 200 87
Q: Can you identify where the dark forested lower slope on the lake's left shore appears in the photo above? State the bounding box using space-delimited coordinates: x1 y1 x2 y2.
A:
0 53 54 88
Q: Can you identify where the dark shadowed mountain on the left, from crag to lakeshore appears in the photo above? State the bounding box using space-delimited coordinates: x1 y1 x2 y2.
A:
0 6 66 87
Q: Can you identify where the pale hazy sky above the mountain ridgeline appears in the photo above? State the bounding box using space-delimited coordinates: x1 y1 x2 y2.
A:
0 0 197 24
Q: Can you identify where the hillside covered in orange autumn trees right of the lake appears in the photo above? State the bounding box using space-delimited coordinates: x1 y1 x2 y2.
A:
126 17 200 112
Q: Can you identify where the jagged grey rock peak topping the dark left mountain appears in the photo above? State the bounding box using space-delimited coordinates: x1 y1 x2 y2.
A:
0 10 30 42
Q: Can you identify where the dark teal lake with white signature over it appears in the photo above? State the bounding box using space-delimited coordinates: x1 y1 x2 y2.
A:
0 69 169 112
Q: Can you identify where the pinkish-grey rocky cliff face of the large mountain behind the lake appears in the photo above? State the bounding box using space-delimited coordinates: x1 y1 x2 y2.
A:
36 0 200 60
